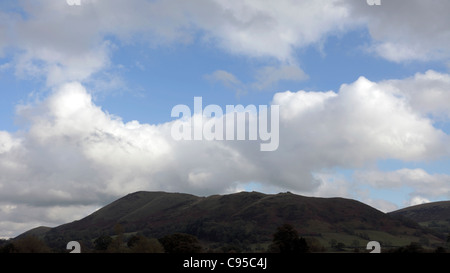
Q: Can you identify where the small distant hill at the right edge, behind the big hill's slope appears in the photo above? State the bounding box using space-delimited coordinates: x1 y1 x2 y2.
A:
389 201 450 237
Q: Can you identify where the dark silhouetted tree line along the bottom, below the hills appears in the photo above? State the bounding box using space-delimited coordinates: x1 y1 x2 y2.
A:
0 224 450 253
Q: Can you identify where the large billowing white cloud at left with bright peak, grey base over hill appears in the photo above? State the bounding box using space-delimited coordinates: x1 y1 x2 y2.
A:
0 83 258 202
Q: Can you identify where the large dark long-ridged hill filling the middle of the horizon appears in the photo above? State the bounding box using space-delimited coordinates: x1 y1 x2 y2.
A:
18 192 443 251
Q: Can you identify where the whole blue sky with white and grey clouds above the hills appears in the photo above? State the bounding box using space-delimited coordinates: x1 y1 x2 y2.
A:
0 0 450 238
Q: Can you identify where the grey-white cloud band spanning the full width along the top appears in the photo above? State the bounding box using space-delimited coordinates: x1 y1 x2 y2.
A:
0 0 450 87
